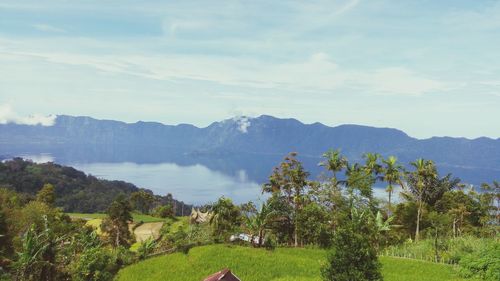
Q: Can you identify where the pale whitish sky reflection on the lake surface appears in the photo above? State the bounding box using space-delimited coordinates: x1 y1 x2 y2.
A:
72 162 260 204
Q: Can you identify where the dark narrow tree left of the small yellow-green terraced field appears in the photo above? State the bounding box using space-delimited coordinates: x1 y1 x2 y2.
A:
101 196 133 248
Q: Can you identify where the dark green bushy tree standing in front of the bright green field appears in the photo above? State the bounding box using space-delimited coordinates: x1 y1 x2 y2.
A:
321 208 382 281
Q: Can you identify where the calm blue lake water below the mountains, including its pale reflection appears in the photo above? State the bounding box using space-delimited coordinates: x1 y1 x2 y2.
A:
13 152 390 205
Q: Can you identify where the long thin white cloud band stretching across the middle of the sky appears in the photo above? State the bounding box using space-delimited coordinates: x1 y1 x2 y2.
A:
0 42 449 96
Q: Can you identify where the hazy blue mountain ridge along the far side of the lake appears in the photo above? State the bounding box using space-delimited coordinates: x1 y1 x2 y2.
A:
0 115 500 184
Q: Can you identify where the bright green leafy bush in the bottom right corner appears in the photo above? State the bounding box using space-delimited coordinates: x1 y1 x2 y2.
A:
459 243 500 281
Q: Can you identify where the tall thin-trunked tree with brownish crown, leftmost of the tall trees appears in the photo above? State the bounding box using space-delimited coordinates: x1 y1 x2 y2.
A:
263 152 309 247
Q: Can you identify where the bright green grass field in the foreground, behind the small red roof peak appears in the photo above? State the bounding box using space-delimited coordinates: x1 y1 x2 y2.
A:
116 245 462 281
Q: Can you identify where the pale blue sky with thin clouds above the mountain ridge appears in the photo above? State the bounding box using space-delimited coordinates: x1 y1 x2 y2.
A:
0 0 500 138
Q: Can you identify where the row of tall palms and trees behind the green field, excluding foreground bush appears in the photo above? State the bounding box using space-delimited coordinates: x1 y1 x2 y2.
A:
207 150 500 246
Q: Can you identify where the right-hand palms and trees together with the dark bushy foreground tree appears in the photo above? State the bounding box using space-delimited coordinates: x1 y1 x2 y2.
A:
200 150 500 280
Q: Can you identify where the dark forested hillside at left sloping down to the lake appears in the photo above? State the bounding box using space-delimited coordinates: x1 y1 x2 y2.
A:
0 158 192 212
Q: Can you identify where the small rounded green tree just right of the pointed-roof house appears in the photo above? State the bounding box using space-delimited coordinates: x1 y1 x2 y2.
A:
210 197 241 240
